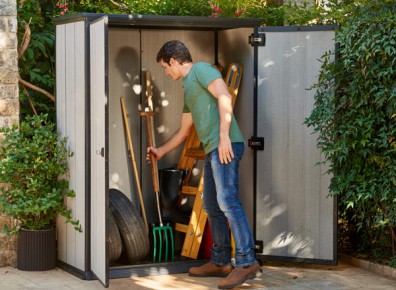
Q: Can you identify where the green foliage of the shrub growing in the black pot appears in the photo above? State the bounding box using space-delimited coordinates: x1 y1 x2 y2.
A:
0 115 80 234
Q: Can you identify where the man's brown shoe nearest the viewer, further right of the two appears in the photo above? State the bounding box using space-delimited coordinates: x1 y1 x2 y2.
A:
218 264 263 289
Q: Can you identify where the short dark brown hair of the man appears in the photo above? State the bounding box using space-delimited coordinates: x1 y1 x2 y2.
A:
157 40 192 65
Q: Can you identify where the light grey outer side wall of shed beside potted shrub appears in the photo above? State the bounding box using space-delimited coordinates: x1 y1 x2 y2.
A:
56 22 86 270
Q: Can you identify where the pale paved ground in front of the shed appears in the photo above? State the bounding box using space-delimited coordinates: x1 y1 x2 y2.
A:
0 260 396 290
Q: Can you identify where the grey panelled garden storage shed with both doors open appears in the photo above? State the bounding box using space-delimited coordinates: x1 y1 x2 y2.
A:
55 13 336 286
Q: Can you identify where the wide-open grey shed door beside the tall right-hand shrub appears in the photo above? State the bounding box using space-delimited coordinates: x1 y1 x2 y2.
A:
256 27 337 264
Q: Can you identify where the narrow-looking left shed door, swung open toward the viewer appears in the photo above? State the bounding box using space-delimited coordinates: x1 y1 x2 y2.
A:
90 17 109 287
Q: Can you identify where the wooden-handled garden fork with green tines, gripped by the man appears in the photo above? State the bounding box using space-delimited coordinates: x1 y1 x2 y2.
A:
140 72 175 263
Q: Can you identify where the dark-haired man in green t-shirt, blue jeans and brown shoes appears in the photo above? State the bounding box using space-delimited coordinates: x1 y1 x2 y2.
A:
147 40 261 289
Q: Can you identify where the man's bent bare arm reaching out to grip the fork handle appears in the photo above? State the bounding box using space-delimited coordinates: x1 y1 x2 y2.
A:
146 113 194 161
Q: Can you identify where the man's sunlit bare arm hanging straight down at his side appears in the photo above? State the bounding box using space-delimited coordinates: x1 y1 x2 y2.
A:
208 78 234 164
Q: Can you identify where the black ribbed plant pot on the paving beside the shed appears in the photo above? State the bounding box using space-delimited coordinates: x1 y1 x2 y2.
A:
17 227 57 271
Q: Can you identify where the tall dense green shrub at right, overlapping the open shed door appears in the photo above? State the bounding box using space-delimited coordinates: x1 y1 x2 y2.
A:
306 0 396 254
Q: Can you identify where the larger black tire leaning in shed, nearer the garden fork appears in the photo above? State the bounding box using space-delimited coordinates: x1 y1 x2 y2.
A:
109 189 150 264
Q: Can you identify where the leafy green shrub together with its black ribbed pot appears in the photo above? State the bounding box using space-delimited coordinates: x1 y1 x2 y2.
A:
0 115 81 271
